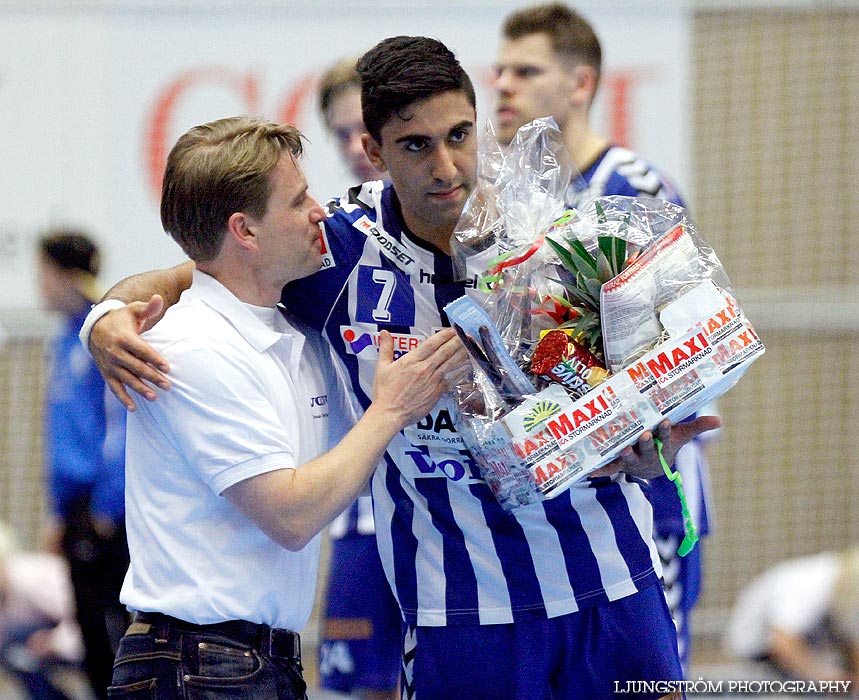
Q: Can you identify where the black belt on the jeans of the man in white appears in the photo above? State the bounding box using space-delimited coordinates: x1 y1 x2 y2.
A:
134 612 301 662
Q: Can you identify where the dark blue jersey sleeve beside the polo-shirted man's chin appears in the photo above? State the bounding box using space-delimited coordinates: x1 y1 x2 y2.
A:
280 209 364 331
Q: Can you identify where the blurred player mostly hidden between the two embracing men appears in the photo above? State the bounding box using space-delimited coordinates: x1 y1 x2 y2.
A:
319 56 402 700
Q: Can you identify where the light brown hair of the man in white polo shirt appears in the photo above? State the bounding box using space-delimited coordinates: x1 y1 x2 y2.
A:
161 117 303 262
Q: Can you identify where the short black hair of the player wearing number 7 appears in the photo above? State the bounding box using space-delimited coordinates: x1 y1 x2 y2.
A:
357 36 477 143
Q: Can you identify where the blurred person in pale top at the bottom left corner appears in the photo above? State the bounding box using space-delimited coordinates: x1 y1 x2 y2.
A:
0 524 83 700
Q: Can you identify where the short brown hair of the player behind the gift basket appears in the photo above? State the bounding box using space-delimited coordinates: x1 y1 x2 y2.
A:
501 3 602 76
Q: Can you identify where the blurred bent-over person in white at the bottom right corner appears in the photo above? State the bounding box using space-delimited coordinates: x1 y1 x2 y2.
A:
726 547 859 693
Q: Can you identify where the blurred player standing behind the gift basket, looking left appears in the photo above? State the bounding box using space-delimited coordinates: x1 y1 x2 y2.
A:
494 3 713 668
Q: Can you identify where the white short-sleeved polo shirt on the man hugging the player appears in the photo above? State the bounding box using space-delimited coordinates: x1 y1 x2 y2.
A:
120 271 342 631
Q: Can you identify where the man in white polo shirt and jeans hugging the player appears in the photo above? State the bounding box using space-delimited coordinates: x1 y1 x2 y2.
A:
113 118 464 700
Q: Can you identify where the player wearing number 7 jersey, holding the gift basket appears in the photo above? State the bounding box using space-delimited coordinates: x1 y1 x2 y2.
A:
84 37 718 700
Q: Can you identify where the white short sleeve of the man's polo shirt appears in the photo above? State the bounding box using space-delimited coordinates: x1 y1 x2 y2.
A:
134 344 298 494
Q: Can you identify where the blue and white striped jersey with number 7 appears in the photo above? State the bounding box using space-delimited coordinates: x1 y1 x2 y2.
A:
283 182 659 626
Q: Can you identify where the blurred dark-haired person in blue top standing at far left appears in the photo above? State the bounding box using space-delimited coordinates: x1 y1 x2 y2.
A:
39 230 129 699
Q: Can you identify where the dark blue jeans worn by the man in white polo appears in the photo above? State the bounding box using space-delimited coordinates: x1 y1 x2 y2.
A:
107 613 306 700
